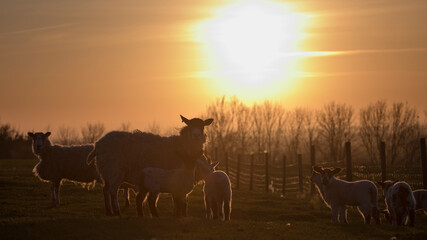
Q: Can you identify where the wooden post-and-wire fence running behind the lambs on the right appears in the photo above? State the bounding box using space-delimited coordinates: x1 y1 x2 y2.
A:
215 138 427 195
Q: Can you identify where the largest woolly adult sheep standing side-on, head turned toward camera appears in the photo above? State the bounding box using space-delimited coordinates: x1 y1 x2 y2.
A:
87 115 213 216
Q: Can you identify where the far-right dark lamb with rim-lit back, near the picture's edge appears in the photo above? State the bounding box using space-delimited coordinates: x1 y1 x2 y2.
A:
377 180 416 227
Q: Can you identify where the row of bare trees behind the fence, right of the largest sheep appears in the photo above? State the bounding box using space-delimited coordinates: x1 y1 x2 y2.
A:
205 96 427 165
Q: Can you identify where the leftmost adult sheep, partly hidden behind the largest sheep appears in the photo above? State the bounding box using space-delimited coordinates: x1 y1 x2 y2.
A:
28 132 135 207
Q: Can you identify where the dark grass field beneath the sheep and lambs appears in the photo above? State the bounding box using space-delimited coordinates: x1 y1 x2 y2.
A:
0 159 427 240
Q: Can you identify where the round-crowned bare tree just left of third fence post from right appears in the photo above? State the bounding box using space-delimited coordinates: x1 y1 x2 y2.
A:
317 102 353 162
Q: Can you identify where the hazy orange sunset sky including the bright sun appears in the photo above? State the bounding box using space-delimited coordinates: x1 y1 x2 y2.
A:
0 0 427 134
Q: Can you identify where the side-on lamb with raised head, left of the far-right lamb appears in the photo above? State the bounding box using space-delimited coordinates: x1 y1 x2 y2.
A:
311 167 380 224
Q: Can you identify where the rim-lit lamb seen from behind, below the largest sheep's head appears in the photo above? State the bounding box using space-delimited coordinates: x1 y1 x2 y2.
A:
200 162 232 221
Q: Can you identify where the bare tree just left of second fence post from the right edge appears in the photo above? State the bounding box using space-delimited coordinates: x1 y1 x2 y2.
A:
359 101 390 164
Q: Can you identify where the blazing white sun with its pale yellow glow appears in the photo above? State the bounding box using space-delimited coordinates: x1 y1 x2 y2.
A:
196 0 308 100
